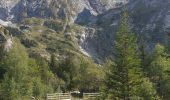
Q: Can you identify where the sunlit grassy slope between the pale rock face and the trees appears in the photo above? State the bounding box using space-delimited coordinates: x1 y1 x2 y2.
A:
15 18 90 59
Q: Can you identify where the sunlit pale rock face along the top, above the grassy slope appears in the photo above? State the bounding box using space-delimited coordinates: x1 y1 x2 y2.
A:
0 0 127 21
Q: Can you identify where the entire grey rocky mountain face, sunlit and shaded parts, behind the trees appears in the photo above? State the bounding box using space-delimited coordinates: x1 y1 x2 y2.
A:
0 0 170 62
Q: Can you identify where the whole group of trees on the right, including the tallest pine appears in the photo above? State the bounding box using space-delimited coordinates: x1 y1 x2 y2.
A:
102 12 170 100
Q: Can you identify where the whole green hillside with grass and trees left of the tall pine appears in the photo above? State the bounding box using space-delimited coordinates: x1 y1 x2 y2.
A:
0 18 103 100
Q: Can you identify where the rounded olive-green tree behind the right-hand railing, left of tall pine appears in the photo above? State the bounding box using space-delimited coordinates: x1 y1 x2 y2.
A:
78 58 104 92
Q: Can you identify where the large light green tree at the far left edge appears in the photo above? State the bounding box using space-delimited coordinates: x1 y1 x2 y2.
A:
0 38 32 100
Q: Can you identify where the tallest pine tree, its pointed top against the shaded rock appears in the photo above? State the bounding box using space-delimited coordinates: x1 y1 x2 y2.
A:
105 12 159 100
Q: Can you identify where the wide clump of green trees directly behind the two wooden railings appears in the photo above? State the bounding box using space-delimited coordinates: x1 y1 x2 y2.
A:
50 54 102 92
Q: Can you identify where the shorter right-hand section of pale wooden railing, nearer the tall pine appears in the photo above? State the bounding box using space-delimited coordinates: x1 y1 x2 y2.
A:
83 93 100 100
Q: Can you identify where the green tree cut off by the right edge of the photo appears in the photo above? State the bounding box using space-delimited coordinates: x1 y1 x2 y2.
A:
148 44 170 100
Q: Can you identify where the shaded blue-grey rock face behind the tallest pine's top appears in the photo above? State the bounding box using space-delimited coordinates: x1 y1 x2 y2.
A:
78 0 170 61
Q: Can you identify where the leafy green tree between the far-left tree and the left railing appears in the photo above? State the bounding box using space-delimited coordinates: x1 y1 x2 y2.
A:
29 57 58 99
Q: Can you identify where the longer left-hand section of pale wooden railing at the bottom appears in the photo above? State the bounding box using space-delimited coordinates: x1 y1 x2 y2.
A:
47 93 71 100
